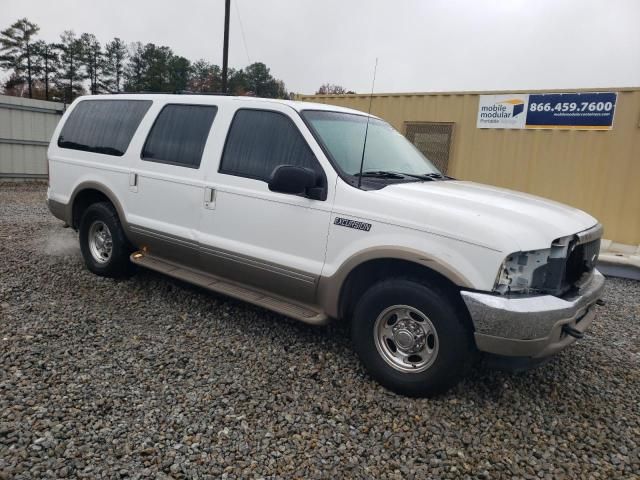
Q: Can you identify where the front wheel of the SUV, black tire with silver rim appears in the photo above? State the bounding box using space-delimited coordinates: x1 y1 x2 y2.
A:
351 279 475 397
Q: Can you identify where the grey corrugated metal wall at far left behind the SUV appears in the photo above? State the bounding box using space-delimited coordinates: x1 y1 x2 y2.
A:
0 95 64 178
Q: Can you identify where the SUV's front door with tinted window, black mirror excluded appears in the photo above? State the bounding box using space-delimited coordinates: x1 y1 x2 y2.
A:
200 104 336 303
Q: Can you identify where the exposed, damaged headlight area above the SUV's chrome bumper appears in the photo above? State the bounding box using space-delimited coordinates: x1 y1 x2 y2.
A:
493 235 573 294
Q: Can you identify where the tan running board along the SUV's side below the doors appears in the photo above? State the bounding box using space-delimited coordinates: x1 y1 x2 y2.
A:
130 251 329 325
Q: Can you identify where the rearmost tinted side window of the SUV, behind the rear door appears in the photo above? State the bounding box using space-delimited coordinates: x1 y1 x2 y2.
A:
58 100 151 157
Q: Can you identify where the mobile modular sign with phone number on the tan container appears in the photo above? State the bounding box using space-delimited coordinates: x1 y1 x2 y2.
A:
477 92 618 130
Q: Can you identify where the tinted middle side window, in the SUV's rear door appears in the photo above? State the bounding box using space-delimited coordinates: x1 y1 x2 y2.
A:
142 105 218 168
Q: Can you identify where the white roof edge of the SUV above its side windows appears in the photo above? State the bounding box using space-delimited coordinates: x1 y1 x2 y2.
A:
78 93 370 118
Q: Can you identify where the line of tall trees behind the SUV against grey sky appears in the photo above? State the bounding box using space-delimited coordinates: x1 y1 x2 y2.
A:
0 18 290 102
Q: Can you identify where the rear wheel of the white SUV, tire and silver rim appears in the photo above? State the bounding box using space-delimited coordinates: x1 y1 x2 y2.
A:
80 202 134 278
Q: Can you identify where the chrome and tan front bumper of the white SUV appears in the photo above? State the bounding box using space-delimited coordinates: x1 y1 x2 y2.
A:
461 269 604 359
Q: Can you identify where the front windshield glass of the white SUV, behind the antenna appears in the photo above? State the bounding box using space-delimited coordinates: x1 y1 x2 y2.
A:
302 110 440 175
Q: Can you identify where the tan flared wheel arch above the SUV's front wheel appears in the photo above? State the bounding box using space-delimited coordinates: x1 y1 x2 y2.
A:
318 247 473 318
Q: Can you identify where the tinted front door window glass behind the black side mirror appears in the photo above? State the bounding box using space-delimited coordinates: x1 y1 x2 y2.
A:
220 110 322 181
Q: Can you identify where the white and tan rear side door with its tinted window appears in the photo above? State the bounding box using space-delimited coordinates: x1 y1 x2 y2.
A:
127 103 218 266
